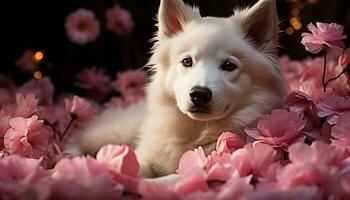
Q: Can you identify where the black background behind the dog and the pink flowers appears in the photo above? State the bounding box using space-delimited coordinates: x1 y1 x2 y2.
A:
0 0 350 93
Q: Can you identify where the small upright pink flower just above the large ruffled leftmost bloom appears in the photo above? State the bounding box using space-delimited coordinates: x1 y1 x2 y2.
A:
15 94 39 117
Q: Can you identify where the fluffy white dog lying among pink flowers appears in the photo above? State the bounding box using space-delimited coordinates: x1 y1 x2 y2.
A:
81 0 285 177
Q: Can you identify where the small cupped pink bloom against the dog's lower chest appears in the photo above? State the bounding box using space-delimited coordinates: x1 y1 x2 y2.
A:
216 132 244 154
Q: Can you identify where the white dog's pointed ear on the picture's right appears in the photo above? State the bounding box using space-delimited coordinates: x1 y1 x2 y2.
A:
233 0 279 54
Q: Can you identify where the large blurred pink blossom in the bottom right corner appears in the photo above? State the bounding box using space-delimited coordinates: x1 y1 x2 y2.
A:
284 141 346 199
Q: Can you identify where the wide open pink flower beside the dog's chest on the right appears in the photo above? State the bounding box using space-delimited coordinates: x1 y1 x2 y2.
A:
245 109 305 148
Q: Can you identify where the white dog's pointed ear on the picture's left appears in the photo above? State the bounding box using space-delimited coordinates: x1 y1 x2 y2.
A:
157 0 200 41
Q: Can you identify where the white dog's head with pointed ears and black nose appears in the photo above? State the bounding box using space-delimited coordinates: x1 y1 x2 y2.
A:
151 0 283 121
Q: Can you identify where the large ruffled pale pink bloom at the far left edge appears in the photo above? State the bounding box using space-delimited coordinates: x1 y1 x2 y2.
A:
4 115 52 158
